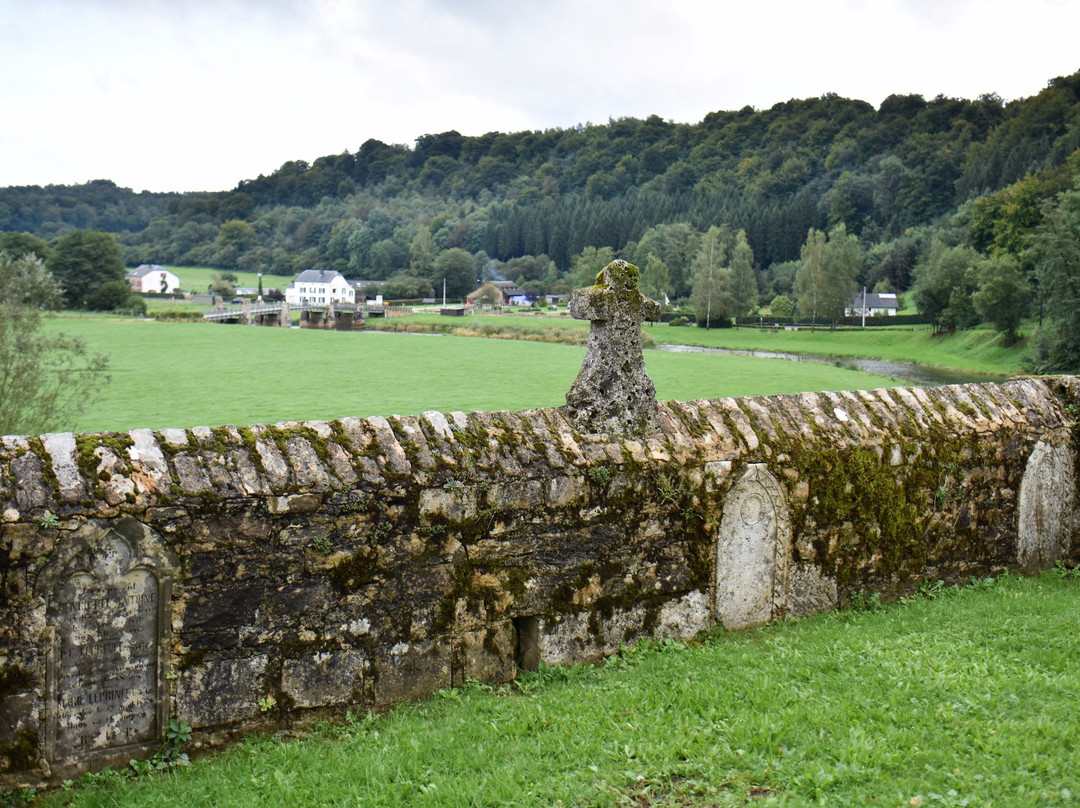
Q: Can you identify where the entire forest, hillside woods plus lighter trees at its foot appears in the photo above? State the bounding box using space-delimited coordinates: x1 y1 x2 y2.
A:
0 72 1080 369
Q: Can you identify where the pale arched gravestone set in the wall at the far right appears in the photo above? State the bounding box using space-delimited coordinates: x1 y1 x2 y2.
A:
1016 441 1076 573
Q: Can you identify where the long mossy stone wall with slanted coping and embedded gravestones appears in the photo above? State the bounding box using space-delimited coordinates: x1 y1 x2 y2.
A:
0 377 1080 785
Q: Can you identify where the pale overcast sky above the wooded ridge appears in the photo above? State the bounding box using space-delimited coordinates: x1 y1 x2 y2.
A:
0 0 1080 191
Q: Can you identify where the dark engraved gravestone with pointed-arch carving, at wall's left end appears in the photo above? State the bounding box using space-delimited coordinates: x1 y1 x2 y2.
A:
37 520 176 769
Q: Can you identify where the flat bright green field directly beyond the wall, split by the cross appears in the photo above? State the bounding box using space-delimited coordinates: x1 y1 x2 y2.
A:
48 317 895 431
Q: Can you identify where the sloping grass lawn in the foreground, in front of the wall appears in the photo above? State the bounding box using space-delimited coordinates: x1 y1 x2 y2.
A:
33 573 1080 808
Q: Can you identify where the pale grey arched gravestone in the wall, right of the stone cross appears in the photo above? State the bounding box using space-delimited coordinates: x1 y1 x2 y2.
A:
713 463 792 630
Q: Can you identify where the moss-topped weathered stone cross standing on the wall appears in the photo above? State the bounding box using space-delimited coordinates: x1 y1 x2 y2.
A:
562 260 660 435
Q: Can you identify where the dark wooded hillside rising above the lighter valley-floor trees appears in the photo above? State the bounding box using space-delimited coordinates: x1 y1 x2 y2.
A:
0 73 1080 277
